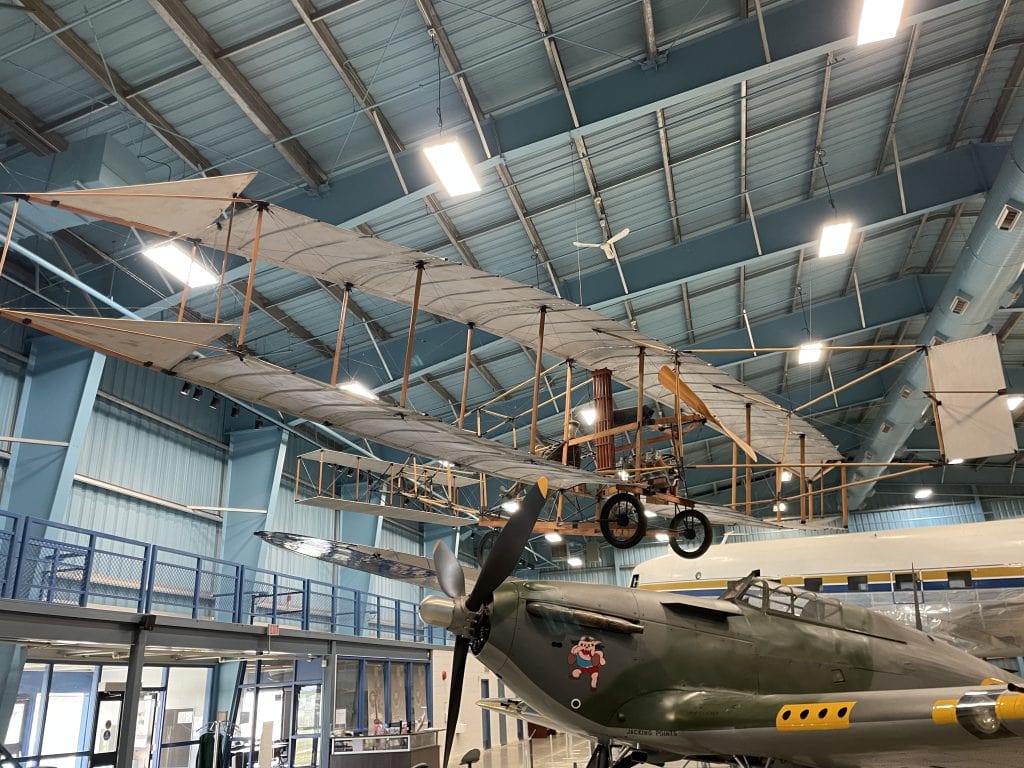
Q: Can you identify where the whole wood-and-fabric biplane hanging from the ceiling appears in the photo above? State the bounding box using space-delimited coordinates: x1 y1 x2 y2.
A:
0 174 1007 557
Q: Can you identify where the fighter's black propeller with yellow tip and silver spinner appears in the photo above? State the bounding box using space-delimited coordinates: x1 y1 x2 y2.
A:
420 477 548 767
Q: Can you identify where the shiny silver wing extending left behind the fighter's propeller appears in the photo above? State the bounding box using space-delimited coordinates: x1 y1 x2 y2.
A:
256 530 479 590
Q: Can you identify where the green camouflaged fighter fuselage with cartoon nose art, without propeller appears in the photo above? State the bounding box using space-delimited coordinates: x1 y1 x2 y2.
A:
479 581 1020 766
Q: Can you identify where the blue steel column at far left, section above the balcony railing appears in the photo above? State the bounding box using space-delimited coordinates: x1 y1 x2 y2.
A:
0 336 106 522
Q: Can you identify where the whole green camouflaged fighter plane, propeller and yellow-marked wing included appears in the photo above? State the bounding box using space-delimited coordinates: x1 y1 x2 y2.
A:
264 481 1024 768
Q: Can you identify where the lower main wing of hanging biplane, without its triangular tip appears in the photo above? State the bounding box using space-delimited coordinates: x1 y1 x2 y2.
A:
174 355 609 488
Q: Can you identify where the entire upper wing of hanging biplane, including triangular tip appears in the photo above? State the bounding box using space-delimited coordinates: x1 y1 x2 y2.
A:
12 180 842 465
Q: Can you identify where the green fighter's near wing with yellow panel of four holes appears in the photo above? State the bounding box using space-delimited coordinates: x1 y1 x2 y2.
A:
623 684 1024 768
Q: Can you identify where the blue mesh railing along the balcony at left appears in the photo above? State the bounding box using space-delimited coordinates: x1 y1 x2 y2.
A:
0 512 451 645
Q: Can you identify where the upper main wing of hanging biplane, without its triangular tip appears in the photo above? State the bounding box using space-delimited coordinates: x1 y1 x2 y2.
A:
214 208 841 464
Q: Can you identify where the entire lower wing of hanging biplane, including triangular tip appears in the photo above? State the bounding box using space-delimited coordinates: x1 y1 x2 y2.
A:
0 309 609 488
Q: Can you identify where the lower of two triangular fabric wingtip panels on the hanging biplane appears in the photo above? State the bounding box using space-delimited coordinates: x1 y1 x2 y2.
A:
0 309 238 370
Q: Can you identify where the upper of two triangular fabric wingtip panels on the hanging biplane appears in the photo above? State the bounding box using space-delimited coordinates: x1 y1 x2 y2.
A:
14 172 256 237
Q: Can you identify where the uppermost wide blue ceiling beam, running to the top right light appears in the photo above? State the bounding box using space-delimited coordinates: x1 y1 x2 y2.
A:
282 0 985 226
